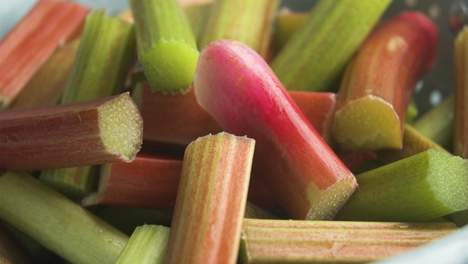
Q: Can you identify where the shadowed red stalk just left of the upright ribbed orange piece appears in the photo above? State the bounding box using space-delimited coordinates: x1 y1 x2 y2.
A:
82 155 182 209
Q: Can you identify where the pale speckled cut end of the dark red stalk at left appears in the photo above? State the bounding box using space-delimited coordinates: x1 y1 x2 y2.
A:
98 93 143 162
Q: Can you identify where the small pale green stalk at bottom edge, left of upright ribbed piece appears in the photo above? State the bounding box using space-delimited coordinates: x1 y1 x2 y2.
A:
116 225 169 264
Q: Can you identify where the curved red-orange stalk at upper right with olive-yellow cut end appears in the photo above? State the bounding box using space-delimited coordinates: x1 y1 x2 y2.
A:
332 12 438 150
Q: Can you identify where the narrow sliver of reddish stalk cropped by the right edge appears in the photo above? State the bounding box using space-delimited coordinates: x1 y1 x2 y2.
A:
454 27 468 158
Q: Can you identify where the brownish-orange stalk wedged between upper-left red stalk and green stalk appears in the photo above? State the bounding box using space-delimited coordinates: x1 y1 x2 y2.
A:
11 40 79 109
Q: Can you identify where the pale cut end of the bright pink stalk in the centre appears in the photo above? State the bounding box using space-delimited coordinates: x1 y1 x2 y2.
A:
306 174 358 220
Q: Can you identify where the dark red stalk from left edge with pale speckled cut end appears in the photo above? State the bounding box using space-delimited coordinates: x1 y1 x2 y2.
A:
0 93 143 170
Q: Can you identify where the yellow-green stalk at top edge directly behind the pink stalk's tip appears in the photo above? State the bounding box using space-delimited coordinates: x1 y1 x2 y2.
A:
201 0 280 58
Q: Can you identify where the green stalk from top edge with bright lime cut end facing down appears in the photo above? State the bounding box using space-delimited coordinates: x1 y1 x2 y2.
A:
130 0 199 93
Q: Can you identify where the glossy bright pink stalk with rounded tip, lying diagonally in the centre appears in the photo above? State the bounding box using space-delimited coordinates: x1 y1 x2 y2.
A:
195 41 357 219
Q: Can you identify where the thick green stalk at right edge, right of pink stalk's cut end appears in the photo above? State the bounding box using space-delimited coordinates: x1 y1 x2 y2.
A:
338 149 468 221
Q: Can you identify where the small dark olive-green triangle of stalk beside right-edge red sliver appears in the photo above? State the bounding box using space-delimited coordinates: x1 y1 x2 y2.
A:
413 96 455 149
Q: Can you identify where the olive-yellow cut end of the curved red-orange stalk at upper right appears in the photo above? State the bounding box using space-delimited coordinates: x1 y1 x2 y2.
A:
332 95 403 150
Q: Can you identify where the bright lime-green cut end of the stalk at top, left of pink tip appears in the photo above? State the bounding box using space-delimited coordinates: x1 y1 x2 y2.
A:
140 41 199 93
